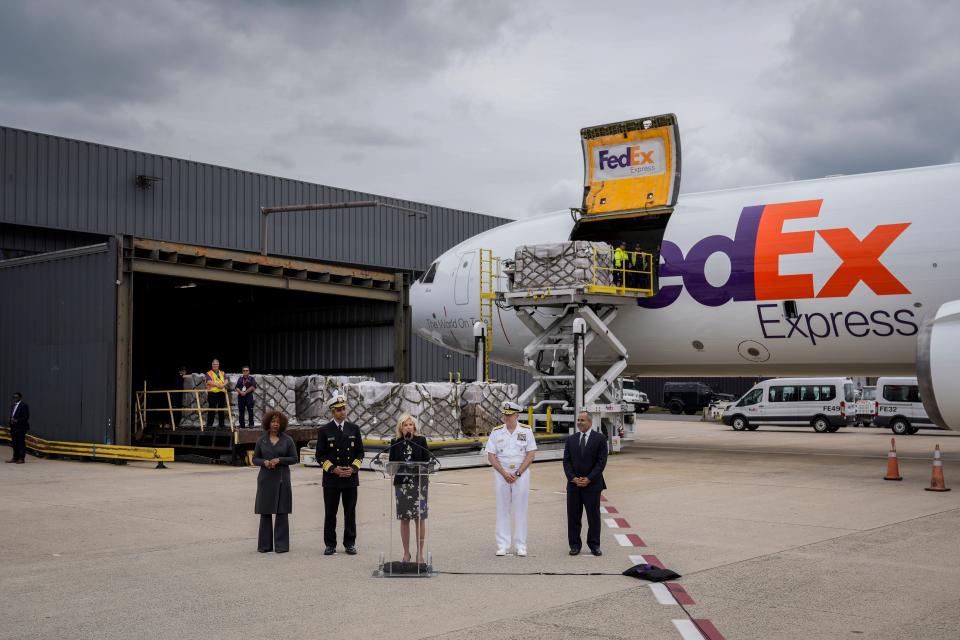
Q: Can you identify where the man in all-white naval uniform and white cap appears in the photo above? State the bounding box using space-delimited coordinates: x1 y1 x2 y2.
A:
486 402 537 557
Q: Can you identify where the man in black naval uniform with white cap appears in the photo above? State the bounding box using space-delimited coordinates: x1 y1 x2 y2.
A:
317 393 363 556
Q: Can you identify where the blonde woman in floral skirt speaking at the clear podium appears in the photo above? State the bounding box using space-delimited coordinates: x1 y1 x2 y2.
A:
390 414 430 564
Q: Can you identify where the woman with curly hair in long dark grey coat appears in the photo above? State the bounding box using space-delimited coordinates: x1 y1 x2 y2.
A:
253 411 298 553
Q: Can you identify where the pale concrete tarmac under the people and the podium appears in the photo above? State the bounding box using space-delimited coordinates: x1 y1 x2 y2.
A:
0 421 960 639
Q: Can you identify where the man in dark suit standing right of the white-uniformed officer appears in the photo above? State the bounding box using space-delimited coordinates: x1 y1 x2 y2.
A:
563 411 607 556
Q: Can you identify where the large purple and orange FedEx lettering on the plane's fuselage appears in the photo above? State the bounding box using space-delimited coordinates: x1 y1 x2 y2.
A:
639 200 910 309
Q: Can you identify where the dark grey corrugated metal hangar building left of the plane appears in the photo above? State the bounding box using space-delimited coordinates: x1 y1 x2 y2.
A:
0 127 523 444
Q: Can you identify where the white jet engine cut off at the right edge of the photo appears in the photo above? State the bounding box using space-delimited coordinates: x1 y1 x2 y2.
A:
917 300 960 430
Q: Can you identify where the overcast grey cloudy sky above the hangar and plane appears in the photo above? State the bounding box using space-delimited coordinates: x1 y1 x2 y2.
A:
0 0 960 217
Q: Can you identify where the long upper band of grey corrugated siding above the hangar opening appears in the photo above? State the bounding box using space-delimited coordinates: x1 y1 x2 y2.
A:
0 127 508 270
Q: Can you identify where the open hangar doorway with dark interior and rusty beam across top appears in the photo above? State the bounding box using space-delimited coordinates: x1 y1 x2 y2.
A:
124 238 410 438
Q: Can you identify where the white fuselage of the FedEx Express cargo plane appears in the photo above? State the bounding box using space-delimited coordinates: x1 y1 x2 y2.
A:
411 164 960 376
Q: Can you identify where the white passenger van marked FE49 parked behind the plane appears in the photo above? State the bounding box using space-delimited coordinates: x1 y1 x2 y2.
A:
723 378 857 433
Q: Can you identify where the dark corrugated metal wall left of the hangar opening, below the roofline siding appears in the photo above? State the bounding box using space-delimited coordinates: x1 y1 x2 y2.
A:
0 240 117 443
